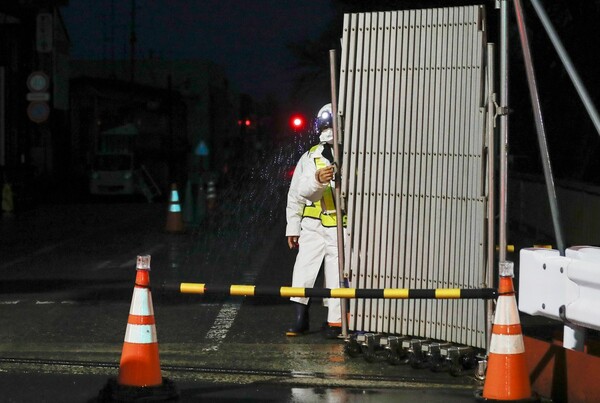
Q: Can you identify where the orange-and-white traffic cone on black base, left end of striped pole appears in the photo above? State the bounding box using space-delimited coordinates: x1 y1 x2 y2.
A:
99 256 178 402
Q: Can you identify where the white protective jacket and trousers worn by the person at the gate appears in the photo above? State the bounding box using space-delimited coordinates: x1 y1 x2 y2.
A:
286 136 342 324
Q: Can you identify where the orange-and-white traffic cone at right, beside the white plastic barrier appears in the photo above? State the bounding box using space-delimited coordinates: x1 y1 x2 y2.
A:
477 262 539 402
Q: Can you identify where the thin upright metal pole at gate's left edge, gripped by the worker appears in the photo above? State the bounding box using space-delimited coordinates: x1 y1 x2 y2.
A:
329 49 348 338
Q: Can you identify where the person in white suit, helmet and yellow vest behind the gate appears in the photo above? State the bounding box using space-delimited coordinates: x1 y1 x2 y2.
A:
286 104 342 338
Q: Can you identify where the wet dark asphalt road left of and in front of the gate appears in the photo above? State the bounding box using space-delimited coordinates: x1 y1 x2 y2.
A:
0 191 488 402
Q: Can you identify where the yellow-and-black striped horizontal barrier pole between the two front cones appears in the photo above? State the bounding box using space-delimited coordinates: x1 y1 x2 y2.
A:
164 283 498 299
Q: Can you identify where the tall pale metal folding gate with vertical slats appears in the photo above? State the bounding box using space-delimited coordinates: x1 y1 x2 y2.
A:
338 6 487 347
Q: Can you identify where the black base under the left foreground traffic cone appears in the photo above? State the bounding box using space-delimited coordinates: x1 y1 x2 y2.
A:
97 378 179 403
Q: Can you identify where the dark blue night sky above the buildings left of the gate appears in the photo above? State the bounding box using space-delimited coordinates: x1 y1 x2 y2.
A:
62 0 333 98
